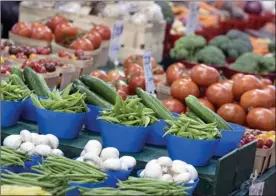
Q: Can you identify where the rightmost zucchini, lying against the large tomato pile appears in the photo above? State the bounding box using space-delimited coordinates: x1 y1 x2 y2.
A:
185 95 232 130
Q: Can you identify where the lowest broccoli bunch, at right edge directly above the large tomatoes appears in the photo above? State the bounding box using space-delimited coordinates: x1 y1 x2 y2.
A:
231 52 276 74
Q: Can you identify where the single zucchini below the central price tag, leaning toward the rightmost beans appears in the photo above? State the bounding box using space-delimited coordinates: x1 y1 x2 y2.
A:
136 88 175 120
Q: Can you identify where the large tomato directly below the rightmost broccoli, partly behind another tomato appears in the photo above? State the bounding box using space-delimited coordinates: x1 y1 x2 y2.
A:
232 75 262 99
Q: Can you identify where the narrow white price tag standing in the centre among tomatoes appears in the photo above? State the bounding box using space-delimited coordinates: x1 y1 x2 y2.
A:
143 52 156 95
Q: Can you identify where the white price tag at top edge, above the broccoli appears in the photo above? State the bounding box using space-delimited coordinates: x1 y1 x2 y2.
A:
186 2 200 35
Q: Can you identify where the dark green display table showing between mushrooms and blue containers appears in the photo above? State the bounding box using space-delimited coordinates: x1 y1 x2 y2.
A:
1 122 256 196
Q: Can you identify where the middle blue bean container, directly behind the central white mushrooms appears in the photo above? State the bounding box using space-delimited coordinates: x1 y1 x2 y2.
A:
98 120 153 152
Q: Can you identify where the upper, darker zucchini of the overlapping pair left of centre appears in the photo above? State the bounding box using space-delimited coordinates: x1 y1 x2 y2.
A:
80 75 118 105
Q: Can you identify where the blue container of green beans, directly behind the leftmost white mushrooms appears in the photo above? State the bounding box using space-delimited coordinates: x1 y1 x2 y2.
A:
36 108 86 139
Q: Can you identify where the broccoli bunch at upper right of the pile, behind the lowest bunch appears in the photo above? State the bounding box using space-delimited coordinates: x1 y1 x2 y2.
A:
209 29 253 59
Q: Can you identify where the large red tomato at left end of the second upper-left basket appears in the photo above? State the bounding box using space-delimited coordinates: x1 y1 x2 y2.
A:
55 23 79 45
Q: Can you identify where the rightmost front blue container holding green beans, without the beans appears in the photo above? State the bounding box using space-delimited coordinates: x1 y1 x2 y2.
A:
165 135 219 166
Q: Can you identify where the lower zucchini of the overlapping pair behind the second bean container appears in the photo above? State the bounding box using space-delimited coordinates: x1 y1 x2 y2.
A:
73 84 112 108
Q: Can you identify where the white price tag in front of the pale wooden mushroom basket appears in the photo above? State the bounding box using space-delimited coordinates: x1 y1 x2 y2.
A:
108 20 124 65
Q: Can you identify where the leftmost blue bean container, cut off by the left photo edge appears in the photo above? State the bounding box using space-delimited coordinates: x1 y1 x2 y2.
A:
0 101 25 127
